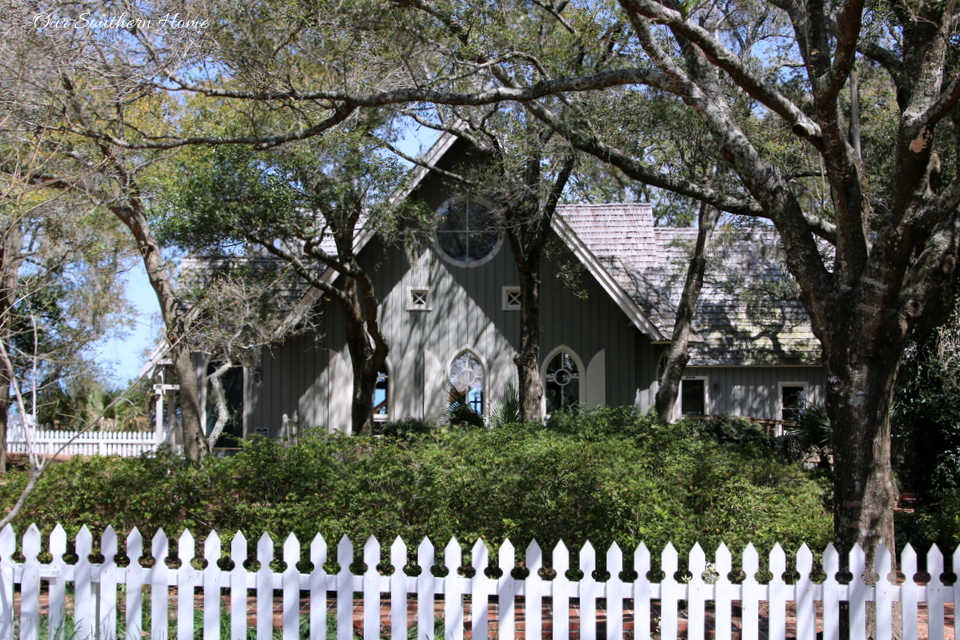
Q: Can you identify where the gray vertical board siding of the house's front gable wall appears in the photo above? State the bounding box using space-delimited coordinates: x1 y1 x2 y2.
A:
248 224 655 435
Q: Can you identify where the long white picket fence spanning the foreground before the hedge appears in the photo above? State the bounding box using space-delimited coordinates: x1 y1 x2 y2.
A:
0 526 960 640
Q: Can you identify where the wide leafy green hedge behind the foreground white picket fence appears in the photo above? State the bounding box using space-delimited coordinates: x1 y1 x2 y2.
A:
0 409 832 551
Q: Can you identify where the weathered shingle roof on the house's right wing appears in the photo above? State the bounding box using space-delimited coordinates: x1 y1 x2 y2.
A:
555 204 820 366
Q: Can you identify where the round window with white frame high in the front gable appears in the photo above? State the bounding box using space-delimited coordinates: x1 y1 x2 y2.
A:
437 198 503 267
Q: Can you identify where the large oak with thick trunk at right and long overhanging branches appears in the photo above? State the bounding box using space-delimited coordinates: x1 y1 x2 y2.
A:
9 0 960 568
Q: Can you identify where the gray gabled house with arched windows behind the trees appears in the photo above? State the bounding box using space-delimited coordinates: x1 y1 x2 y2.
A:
229 144 824 436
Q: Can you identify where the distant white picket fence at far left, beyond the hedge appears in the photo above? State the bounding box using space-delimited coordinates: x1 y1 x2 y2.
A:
7 428 157 457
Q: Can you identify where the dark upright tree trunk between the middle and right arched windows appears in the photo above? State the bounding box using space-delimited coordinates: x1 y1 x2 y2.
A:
508 252 543 422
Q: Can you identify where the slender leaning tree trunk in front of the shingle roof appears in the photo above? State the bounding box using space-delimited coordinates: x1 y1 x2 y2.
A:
656 205 720 424
